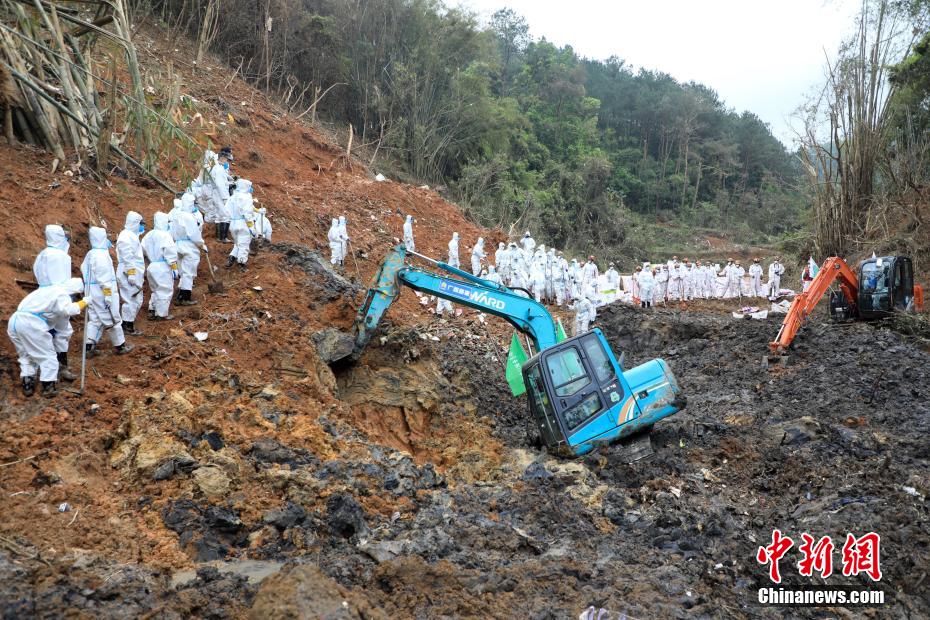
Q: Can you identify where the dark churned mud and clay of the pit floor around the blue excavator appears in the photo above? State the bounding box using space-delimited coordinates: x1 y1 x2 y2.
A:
0 306 930 618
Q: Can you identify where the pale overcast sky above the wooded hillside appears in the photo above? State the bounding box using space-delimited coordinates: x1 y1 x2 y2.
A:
447 0 859 146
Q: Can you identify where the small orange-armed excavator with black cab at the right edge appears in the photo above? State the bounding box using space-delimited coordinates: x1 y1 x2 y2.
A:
769 256 924 355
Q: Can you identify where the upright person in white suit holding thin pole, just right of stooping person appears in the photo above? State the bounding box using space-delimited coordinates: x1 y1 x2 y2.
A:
81 226 133 356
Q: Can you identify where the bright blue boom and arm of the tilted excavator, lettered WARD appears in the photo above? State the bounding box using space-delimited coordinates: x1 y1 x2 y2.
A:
352 245 558 359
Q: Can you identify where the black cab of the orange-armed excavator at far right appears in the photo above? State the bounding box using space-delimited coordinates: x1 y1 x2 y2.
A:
857 256 914 319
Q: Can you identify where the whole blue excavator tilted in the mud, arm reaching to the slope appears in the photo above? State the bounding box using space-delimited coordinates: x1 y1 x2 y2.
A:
340 245 686 456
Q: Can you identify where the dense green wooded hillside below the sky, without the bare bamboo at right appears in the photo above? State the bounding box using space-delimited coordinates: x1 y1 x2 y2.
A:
145 0 805 252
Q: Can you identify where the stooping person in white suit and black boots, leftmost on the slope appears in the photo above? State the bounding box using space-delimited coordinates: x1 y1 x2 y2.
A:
6 278 88 396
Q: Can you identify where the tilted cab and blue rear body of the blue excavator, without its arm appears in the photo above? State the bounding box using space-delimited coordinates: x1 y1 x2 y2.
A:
523 329 685 455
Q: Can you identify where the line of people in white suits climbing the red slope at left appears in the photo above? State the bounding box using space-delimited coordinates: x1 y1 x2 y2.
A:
7 148 271 396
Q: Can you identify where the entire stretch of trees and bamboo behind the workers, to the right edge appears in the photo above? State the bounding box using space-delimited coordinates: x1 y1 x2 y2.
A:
135 0 930 259
